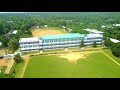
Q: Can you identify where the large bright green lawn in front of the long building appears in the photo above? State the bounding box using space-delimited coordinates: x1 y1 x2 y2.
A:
24 52 120 78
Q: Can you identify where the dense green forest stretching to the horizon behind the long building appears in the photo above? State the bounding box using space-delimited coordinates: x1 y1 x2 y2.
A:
0 12 120 52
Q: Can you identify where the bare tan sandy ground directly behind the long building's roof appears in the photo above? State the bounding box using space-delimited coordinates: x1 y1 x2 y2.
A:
32 29 63 37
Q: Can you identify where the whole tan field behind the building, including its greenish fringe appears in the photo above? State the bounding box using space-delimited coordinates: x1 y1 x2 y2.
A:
32 27 67 37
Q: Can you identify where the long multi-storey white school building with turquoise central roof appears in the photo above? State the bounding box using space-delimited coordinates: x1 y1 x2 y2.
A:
19 29 103 52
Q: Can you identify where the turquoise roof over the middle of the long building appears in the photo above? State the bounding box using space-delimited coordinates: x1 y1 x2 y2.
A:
40 33 84 39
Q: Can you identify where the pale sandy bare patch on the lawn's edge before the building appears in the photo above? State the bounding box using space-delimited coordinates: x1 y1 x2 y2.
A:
59 52 86 63
